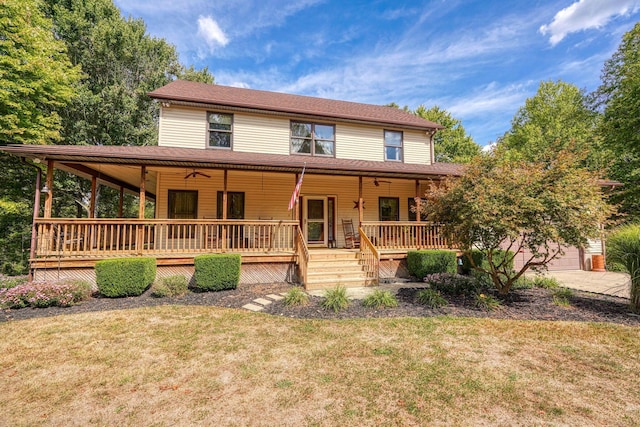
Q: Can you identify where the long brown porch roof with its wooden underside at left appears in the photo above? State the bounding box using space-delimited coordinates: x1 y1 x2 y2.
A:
0 145 462 181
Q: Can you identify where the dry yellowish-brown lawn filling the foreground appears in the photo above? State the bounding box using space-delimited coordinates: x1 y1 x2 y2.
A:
0 306 640 426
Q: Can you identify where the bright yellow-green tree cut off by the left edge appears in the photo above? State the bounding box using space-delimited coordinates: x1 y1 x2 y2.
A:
0 0 80 144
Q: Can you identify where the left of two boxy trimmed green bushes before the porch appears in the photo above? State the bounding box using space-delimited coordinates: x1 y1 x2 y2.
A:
96 258 156 298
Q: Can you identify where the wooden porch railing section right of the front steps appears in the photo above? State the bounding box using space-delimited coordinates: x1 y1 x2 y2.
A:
361 221 450 250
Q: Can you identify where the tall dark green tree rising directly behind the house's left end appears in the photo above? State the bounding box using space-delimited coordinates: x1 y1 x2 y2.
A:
45 0 213 216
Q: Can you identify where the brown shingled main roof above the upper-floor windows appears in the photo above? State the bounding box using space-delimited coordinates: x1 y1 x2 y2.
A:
149 80 443 131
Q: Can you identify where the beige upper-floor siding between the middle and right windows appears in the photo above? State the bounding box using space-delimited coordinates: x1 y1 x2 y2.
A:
336 123 384 162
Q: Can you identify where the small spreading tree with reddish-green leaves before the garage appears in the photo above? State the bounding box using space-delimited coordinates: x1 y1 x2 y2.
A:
423 147 612 295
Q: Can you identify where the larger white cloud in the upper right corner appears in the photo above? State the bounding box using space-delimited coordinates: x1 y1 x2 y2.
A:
540 0 640 46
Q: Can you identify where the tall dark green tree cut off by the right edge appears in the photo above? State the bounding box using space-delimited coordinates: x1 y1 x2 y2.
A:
594 23 640 221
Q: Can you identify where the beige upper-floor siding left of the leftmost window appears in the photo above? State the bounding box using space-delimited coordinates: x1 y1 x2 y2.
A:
158 107 207 149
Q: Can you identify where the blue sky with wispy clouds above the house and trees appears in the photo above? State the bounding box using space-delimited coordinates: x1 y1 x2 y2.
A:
115 0 640 145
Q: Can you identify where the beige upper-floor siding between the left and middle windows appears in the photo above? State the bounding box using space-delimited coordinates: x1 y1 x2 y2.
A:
233 113 290 155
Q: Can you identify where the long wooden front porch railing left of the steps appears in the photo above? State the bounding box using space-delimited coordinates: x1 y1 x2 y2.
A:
36 218 298 258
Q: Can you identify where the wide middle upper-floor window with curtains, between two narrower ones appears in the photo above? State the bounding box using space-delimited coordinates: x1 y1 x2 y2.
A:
291 122 336 157
